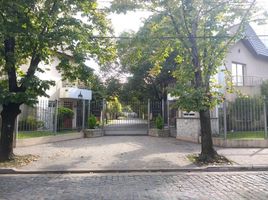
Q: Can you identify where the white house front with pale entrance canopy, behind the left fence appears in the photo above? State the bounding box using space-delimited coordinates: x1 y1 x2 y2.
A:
18 59 92 131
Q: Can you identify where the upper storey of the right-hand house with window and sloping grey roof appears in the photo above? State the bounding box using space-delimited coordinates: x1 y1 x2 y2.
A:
218 25 268 101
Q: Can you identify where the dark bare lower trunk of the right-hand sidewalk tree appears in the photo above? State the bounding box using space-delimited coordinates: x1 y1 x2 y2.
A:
199 109 217 160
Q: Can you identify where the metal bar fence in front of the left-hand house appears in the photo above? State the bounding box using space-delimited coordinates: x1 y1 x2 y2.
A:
0 99 103 138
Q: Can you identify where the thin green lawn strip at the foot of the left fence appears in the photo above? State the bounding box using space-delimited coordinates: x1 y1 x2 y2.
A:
18 130 77 139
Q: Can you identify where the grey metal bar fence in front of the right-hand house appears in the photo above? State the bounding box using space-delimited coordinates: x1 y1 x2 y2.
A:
218 98 268 139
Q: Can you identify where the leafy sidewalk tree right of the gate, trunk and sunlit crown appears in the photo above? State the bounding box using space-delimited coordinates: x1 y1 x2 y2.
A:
111 0 256 161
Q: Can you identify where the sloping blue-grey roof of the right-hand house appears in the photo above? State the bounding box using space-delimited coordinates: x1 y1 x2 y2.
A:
243 25 268 58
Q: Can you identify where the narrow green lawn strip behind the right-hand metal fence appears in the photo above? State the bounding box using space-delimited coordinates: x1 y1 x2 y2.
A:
227 131 265 139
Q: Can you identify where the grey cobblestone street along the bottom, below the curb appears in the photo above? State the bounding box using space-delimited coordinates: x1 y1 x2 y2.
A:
0 172 268 200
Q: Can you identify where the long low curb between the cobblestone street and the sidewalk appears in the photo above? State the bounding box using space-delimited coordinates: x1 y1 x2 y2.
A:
0 166 268 174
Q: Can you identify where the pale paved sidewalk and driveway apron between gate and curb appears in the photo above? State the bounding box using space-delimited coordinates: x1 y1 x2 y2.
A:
8 136 268 171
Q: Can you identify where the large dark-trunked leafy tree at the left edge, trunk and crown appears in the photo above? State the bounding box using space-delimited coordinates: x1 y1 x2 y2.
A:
0 0 114 160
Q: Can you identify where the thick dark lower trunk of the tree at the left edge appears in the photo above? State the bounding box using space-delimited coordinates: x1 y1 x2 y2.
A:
0 103 20 161
